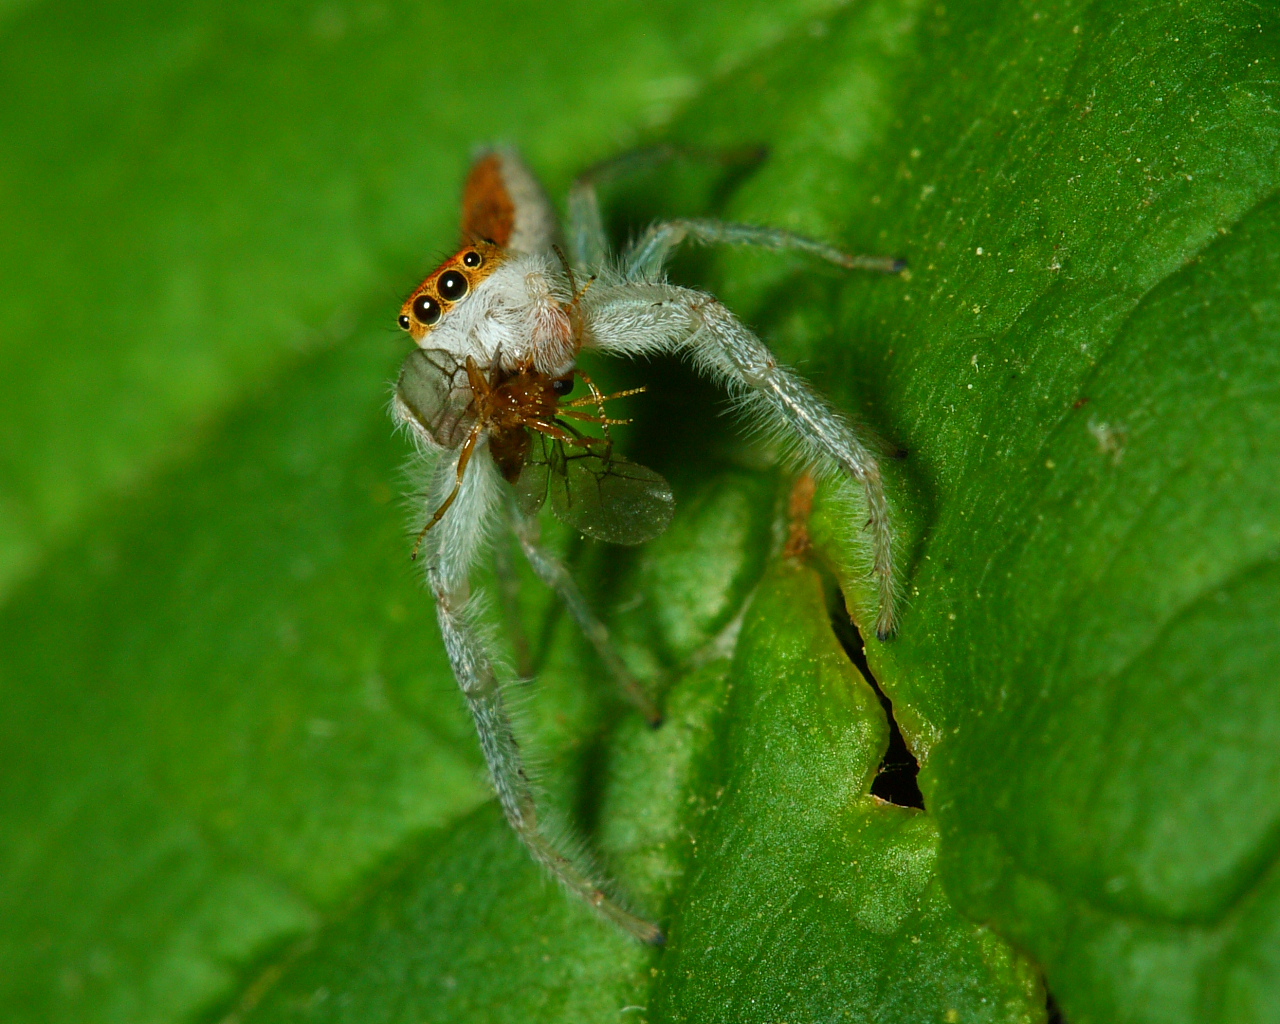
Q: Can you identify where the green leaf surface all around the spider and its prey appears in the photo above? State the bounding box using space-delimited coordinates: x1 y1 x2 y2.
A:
0 0 1280 1024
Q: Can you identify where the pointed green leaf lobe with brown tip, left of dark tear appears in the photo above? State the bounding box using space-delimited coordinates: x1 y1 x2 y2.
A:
655 567 1043 1021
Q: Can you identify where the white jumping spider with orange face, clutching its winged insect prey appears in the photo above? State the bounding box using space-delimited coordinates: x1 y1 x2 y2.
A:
393 150 902 943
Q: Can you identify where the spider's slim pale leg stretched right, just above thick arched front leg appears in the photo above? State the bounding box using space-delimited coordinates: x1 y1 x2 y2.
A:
622 220 906 280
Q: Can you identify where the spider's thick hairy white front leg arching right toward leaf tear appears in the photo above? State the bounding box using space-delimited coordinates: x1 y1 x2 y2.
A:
588 283 896 640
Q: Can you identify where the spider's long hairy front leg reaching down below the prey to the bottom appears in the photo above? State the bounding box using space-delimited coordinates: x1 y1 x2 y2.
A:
425 457 663 945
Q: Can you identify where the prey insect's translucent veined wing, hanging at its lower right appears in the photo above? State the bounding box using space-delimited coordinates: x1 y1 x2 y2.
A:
548 442 676 544
